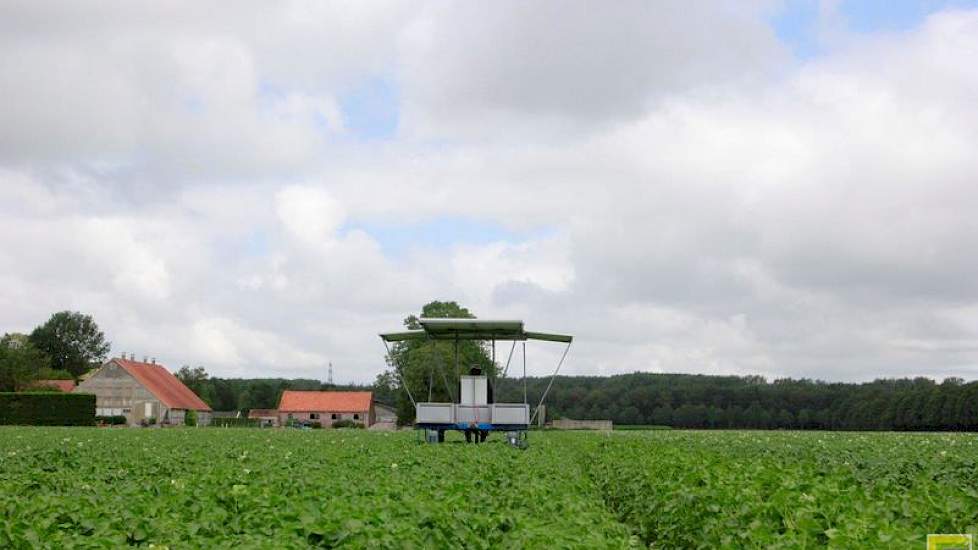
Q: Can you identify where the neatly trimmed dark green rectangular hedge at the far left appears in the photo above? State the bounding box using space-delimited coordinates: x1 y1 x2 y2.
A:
0 392 95 426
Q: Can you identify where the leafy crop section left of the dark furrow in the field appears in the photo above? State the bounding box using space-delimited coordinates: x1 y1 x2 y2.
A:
0 428 630 549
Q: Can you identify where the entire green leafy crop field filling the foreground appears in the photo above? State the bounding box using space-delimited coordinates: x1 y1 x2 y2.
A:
0 428 978 549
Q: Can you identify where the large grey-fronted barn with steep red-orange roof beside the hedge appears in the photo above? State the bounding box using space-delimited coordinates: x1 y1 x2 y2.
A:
74 358 211 425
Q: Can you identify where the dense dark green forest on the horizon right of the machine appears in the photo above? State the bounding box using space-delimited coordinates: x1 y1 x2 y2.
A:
497 373 978 430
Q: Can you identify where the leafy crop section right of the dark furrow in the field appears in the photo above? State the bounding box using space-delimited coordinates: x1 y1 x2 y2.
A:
577 431 978 549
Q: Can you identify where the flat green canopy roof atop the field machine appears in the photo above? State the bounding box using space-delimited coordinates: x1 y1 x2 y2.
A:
380 318 573 343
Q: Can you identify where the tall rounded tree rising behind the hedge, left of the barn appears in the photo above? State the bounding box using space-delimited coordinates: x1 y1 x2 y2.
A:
28 311 110 377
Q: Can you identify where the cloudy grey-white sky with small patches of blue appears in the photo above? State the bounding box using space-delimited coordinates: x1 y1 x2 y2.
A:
0 0 978 382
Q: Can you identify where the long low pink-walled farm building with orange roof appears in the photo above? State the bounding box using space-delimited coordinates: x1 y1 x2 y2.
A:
278 390 374 427
